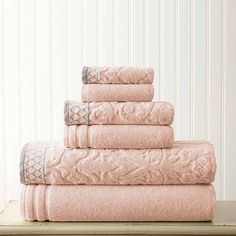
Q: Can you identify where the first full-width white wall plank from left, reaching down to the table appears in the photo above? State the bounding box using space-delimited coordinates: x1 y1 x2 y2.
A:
4 0 19 199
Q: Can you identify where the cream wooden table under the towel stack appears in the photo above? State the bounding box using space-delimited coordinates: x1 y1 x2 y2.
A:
0 201 236 236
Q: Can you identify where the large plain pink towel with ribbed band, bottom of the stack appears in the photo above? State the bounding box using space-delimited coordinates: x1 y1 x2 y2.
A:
21 185 216 221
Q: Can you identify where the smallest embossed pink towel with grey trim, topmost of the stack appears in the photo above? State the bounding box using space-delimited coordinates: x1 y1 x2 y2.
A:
82 67 154 84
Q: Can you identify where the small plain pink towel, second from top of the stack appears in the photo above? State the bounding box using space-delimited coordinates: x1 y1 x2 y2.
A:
82 84 154 102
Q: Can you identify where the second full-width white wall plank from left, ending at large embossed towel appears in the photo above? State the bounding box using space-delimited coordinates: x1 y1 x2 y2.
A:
19 0 37 143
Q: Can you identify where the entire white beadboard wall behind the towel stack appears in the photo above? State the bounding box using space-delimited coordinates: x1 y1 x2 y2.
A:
0 0 236 207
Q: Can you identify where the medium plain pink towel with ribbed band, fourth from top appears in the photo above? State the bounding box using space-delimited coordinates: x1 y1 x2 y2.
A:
64 125 174 148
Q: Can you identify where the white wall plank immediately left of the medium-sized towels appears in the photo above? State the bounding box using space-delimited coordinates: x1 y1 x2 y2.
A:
51 0 68 140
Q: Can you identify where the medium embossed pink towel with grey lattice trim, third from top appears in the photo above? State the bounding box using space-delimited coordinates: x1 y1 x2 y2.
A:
64 101 174 125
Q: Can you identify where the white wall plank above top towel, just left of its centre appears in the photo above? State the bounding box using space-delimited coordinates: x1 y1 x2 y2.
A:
98 0 113 65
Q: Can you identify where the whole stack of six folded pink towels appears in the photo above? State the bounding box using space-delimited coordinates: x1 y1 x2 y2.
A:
20 67 216 221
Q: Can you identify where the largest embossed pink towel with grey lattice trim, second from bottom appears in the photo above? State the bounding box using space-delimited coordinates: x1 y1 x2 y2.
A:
20 141 216 185
